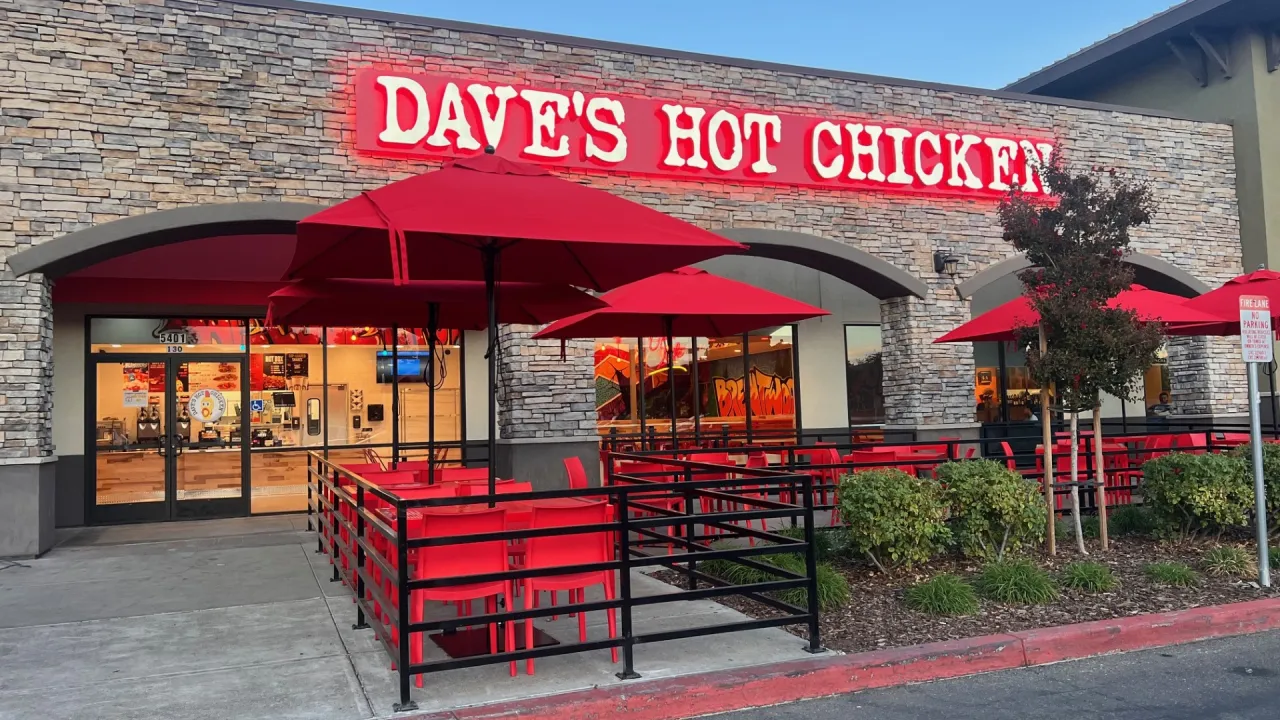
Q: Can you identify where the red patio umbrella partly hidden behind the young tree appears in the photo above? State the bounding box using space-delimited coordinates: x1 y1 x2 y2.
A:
933 284 1221 342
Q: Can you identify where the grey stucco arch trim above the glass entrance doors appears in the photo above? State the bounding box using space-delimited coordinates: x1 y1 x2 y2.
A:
9 202 317 278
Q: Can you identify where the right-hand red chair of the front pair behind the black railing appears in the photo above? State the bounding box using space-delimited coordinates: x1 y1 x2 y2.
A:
519 502 618 675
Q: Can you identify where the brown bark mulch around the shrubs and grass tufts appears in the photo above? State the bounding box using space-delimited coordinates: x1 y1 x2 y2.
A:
654 538 1280 652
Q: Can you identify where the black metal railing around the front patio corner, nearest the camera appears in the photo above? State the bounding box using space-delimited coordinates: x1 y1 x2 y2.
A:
307 454 822 710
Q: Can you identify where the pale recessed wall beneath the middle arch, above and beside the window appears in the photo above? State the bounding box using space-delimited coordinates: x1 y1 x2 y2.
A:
699 255 881 428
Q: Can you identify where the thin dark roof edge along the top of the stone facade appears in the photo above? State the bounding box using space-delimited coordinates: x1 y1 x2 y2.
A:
225 0 1230 124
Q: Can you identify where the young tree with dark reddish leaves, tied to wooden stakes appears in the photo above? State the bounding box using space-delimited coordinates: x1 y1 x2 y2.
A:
1000 161 1164 553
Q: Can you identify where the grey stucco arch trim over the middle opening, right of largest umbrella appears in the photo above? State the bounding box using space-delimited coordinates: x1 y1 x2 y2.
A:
716 228 929 300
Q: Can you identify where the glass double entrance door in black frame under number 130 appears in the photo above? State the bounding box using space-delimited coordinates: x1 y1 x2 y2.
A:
87 354 248 524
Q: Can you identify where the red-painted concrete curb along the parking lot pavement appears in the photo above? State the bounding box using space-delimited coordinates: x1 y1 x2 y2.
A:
415 598 1280 720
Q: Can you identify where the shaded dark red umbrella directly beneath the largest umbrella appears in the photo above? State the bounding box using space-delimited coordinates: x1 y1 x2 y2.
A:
266 279 605 478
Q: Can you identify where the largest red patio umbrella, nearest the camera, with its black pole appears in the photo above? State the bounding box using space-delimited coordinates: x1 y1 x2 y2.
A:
285 147 745 486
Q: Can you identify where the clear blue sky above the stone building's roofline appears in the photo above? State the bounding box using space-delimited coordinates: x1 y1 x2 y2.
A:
330 0 1174 87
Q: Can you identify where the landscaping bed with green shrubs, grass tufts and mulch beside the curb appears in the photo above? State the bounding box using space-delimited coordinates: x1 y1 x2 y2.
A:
658 447 1280 652
